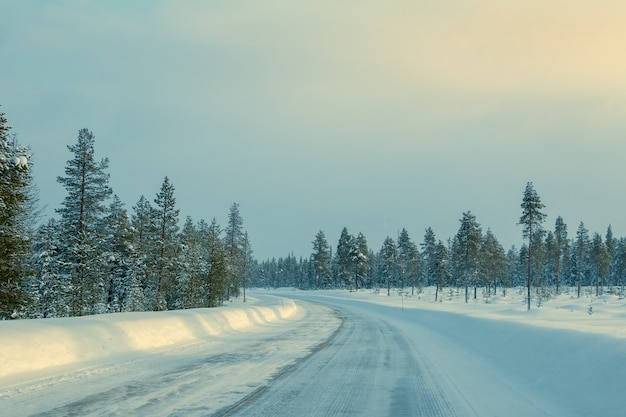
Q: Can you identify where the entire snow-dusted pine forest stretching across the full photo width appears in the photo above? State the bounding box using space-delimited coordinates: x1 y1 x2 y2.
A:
0 105 626 319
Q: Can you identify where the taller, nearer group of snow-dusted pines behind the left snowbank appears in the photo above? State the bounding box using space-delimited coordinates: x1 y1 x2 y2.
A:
0 108 252 319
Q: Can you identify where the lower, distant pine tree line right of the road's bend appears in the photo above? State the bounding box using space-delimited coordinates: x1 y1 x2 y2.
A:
252 183 626 309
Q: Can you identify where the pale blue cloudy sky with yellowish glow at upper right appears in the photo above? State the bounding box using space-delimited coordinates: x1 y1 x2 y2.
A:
0 0 626 259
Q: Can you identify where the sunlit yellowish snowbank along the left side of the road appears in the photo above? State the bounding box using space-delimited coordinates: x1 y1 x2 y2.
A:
0 297 296 378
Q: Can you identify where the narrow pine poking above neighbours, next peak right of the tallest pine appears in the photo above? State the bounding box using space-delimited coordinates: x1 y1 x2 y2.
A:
154 177 179 311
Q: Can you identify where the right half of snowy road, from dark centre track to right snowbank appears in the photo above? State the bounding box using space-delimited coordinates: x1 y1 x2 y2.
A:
223 293 571 417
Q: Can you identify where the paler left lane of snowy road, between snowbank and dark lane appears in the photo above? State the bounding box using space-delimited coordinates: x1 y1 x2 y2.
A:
0 296 341 417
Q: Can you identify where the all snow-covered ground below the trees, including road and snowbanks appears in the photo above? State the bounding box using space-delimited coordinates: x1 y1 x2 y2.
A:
0 288 626 417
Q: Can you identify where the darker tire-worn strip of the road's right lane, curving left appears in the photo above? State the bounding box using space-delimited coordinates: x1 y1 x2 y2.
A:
226 306 467 417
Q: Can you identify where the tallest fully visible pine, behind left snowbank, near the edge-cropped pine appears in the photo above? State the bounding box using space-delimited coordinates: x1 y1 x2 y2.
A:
57 129 112 316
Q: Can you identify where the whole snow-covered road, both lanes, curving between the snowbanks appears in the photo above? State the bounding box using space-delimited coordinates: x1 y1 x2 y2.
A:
0 293 580 417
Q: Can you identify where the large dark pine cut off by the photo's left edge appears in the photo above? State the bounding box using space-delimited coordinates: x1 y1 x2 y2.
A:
0 109 32 319
